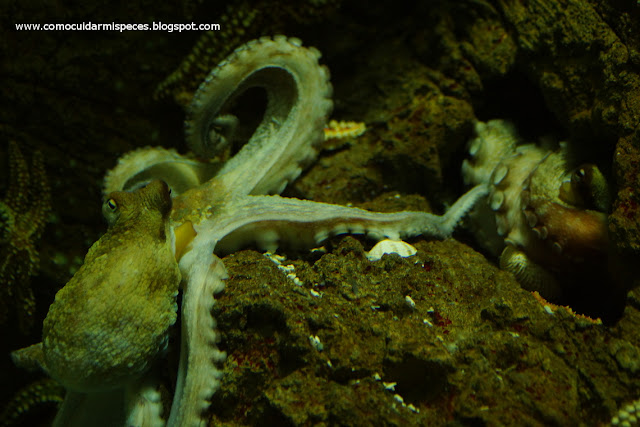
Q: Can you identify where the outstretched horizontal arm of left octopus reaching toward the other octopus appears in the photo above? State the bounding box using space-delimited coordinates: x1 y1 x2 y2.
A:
196 186 486 253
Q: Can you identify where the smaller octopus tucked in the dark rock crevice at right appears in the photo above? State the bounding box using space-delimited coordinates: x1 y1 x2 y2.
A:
462 120 611 306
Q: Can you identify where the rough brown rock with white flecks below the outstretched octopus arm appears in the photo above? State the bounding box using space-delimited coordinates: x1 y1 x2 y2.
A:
211 237 640 425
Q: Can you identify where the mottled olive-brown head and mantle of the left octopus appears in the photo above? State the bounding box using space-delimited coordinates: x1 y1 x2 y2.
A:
43 181 180 392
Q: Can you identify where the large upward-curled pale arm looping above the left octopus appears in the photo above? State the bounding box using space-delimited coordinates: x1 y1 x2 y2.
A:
185 36 333 198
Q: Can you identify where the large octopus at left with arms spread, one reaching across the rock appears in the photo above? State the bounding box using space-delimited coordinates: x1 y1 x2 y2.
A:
14 36 487 426
